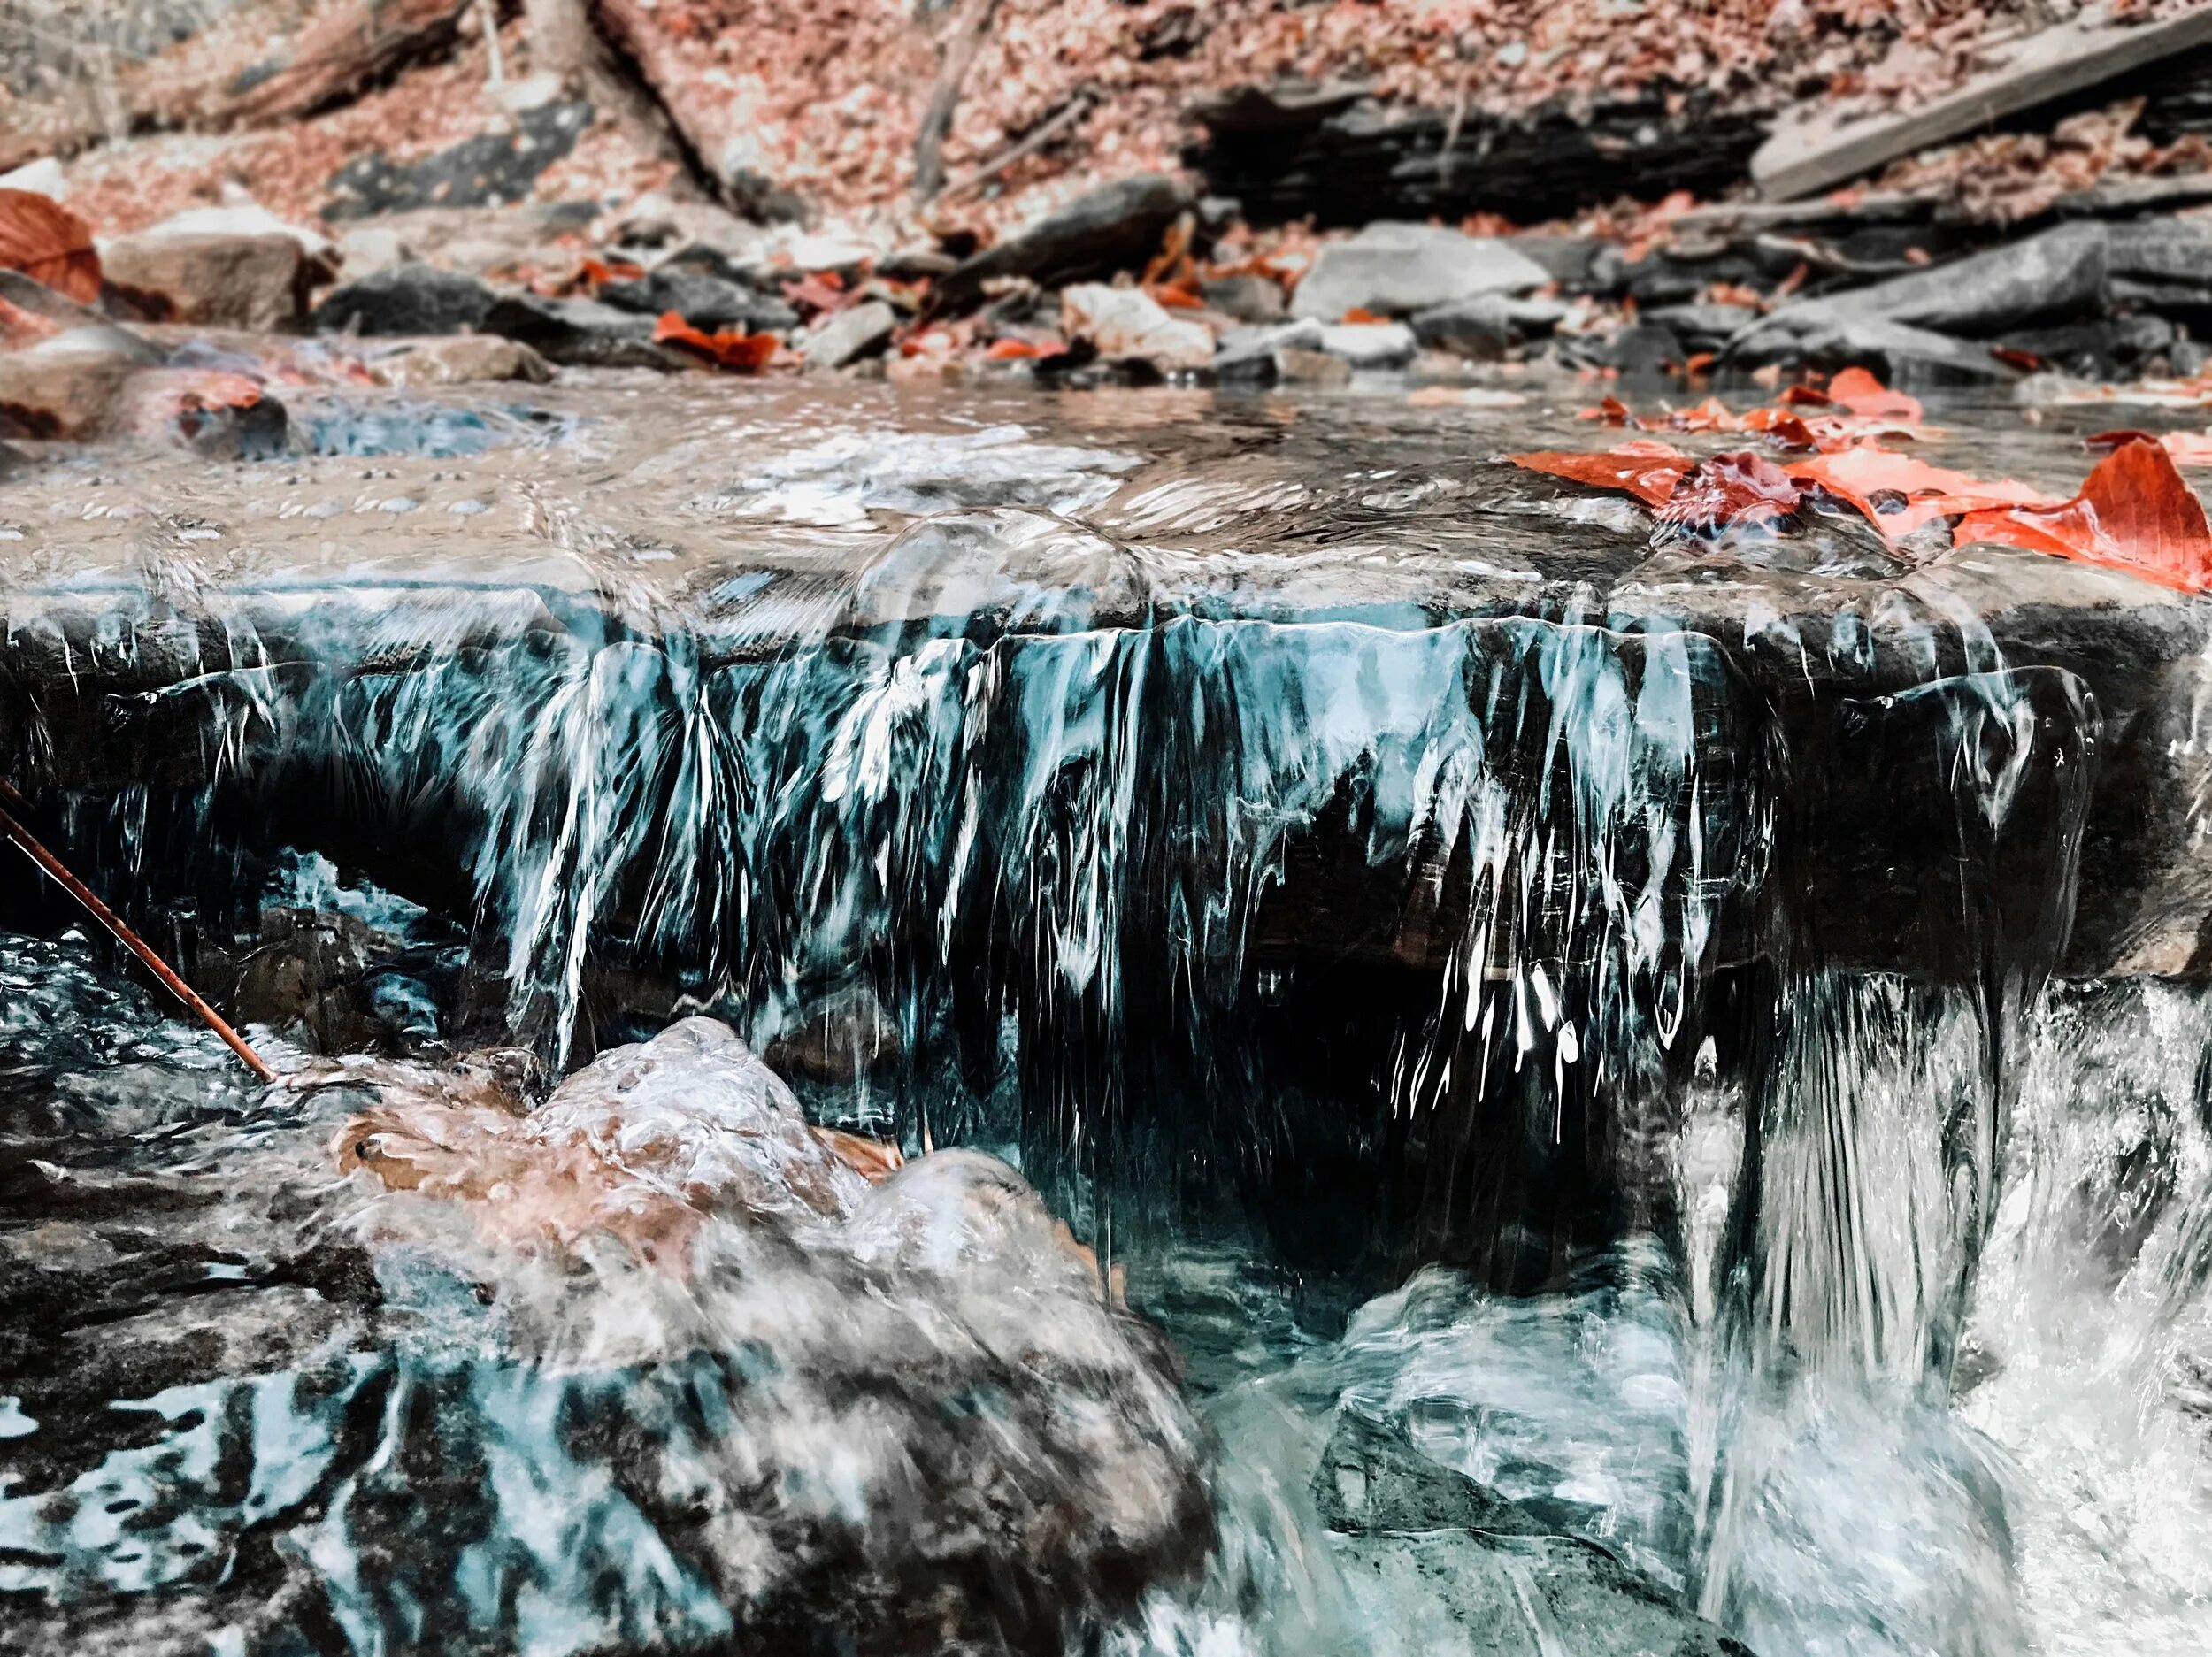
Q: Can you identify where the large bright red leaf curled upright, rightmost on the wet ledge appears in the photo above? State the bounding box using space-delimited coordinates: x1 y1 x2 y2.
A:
1954 442 2212 593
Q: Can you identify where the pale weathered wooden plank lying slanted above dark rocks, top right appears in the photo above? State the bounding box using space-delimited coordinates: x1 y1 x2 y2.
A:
1752 7 2212 202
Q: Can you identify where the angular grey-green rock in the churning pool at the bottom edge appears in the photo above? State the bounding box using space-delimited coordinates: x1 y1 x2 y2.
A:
1314 1411 1750 1657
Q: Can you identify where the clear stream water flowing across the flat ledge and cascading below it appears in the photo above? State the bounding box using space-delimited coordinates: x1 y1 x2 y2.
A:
0 364 2212 1657
